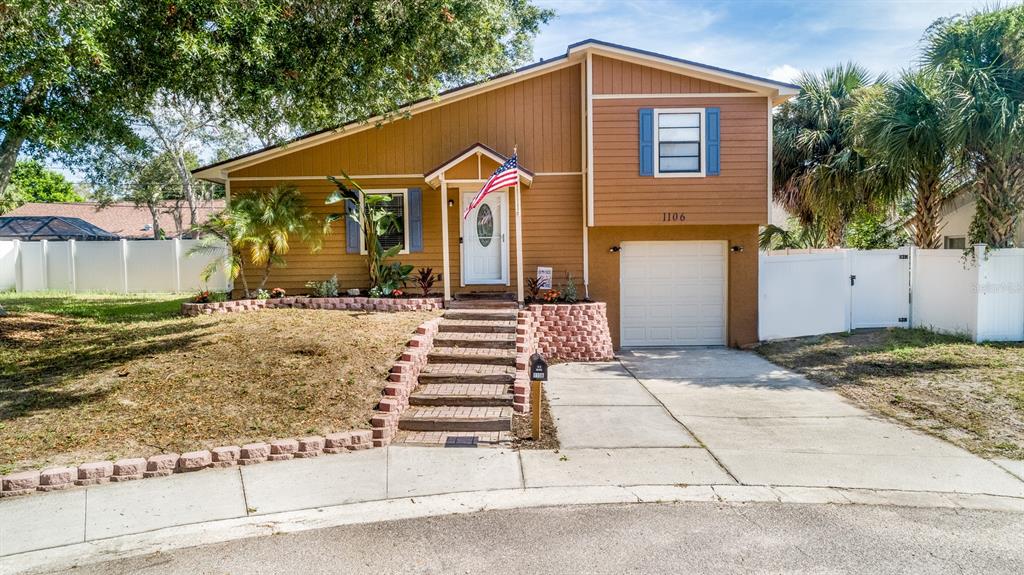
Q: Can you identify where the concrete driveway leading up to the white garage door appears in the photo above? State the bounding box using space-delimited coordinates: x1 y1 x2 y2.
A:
547 348 1024 497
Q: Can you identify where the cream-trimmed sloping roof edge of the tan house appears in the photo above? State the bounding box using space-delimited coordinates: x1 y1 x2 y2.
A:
191 39 800 182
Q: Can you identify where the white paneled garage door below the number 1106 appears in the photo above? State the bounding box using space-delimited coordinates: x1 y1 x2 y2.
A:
620 241 727 347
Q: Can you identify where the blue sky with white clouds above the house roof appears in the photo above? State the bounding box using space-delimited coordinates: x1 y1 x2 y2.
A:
534 0 1009 82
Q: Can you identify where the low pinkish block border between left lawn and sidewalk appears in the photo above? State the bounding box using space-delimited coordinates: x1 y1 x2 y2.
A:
0 430 373 497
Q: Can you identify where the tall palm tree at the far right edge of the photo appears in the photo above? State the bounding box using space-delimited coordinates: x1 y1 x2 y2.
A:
924 6 1024 248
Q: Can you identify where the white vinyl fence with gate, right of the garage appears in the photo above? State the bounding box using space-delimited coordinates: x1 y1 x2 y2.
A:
759 246 1024 342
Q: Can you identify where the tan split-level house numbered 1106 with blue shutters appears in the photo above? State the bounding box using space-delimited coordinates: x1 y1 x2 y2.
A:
195 40 799 347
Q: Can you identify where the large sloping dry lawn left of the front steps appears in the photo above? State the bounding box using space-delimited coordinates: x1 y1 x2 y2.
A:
0 294 434 475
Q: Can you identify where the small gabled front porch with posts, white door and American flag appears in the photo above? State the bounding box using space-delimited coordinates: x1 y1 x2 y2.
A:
425 143 534 302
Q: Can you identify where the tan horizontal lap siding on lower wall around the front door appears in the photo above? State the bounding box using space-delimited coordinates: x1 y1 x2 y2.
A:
232 176 583 295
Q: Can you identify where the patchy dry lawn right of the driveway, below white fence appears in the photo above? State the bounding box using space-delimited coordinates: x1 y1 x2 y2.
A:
758 329 1024 459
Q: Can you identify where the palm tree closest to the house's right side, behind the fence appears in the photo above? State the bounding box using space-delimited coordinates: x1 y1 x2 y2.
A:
772 62 870 246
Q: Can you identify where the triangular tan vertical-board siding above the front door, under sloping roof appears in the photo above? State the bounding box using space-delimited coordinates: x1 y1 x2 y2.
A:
230 65 582 178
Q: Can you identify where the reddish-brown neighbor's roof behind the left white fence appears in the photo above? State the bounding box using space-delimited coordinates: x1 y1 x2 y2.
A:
4 200 224 239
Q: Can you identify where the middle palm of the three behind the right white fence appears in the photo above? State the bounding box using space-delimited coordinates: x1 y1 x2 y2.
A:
851 71 964 249
